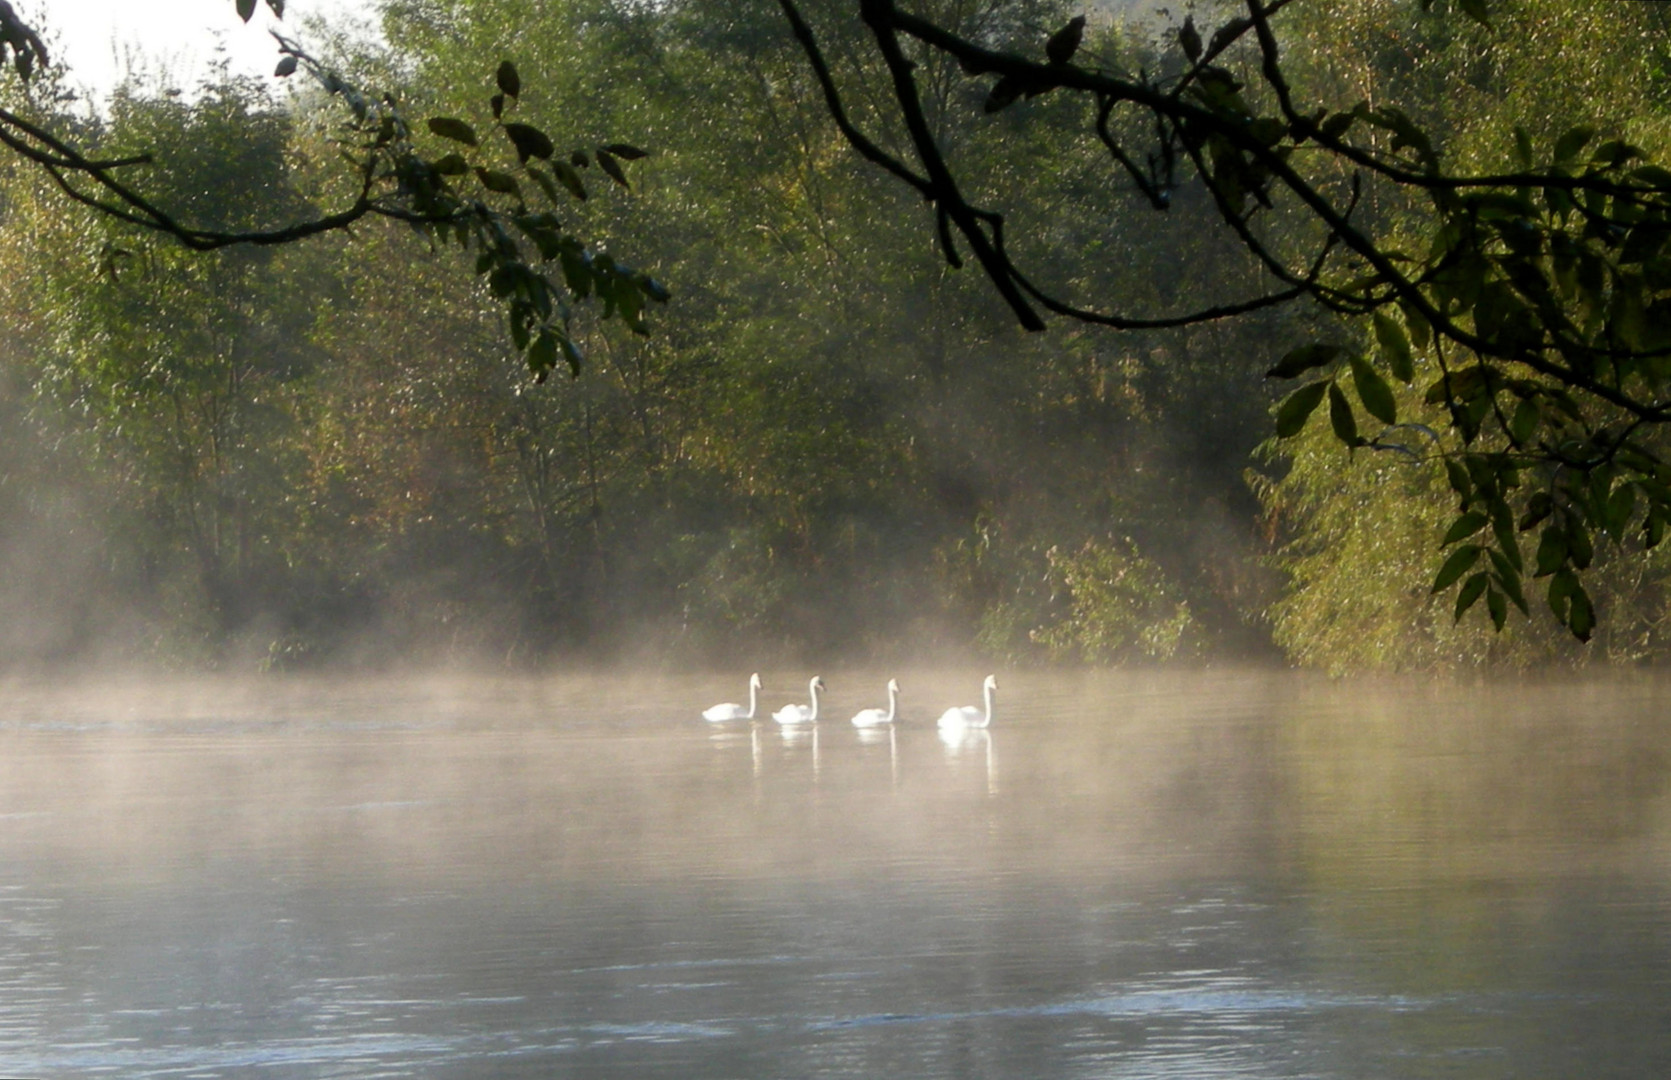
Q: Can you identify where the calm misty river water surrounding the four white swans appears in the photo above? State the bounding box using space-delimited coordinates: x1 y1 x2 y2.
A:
0 670 1671 1080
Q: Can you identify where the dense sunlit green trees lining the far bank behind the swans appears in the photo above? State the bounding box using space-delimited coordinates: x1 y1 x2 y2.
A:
0 0 1671 667
